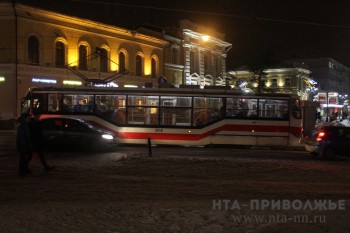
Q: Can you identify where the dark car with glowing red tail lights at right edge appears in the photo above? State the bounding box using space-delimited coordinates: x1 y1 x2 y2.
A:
305 126 350 159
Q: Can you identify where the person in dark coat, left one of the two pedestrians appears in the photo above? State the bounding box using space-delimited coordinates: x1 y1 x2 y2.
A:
16 113 32 177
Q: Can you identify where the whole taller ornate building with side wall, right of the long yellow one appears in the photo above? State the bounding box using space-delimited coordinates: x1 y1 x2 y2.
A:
138 20 232 88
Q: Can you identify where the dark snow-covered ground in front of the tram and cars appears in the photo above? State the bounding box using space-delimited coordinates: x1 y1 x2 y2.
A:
0 148 350 233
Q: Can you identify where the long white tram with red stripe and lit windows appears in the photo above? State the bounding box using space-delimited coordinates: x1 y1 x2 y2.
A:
21 87 303 146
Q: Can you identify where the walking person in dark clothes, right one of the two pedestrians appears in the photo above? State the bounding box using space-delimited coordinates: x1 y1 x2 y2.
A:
29 114 54 172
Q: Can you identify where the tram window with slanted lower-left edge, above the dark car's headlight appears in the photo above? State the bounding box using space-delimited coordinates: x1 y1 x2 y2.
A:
95 95 126 124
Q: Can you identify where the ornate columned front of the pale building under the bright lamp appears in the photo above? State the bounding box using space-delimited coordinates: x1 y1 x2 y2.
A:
180 20 232 87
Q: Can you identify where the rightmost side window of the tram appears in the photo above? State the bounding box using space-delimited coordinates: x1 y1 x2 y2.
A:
259 99 289 119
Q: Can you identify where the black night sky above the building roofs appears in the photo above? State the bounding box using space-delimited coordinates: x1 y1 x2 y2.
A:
13 0 350 70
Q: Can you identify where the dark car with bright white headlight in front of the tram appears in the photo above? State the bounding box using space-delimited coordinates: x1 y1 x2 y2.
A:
41 117 117 149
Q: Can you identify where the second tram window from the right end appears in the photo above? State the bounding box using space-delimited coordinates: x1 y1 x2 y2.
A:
226 98 258 118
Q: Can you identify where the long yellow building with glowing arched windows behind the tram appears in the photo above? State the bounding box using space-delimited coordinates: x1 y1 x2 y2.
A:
0 3 169 120
